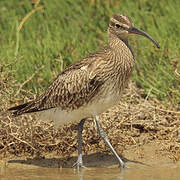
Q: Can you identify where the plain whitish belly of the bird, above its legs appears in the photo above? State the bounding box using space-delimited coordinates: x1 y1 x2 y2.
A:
39 93 119 128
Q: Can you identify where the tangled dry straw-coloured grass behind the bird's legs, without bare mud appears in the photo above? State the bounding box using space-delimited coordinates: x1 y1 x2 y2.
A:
0 66 180 161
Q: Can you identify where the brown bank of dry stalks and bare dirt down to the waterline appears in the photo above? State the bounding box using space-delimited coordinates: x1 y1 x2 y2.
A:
0 79 180 167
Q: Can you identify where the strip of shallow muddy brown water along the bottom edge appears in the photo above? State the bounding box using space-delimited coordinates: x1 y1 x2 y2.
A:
0 164 180 180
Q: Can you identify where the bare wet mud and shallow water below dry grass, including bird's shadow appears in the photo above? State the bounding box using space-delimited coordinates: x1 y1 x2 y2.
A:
0 143 180 180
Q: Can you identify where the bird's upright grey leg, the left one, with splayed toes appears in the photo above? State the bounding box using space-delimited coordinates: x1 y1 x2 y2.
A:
73 119 85 170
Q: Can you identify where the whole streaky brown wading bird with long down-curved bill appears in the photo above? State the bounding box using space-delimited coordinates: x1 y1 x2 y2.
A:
8 14 160 169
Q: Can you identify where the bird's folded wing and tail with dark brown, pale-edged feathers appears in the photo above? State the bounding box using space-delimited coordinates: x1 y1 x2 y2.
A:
9 56 104 116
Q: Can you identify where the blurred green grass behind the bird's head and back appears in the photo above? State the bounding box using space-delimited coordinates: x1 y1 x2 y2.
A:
0 0 180 104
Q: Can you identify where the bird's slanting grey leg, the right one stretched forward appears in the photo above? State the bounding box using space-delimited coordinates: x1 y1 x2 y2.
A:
95 116 126 169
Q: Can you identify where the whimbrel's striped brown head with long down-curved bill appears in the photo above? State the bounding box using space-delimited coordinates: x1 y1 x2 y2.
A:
108 14 160 48
